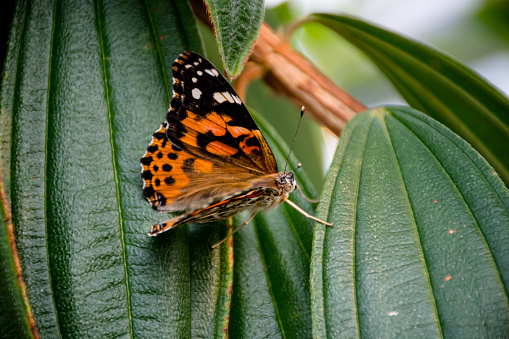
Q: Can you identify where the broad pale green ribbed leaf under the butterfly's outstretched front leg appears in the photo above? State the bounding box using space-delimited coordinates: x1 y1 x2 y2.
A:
311 106 509 338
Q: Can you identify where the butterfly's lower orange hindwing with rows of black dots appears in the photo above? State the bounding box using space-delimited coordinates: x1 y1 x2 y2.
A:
140 121 268 212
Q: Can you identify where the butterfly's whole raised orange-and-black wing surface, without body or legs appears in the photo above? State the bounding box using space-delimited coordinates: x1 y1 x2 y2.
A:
141 52 277 211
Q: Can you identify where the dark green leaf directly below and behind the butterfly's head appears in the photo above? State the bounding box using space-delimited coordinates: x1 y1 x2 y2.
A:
229 111 315 338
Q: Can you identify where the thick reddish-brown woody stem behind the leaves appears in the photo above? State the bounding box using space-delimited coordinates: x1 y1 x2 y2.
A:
190 0 367 136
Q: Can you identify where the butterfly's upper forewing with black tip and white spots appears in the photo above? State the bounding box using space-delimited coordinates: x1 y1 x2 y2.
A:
166 52 277 175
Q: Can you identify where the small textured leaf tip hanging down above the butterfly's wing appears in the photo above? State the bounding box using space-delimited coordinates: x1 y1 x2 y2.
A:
206 0 265 78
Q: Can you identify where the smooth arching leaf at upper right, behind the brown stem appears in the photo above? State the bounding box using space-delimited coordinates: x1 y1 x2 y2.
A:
311 14 509 184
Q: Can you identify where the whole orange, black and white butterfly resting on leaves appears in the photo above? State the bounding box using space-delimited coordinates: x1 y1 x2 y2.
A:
140 51 332 245
